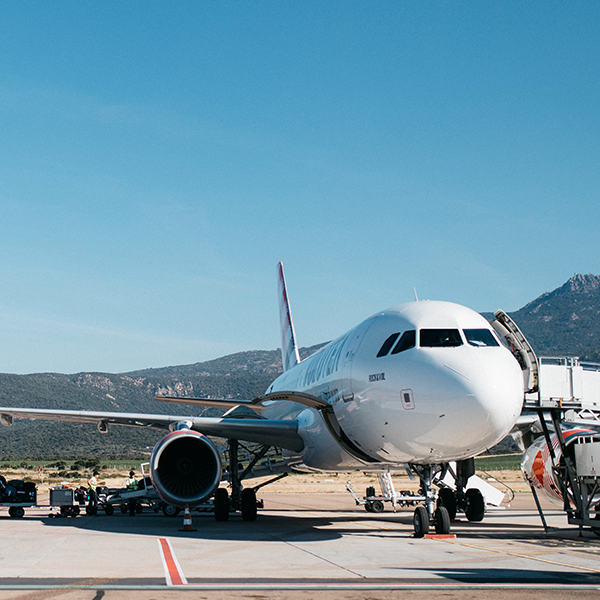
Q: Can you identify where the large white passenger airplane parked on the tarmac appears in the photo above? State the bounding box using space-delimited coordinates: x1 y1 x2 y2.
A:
0 263 524 537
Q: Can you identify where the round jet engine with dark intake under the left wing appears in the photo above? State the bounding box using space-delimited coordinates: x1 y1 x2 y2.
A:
150 429 222 508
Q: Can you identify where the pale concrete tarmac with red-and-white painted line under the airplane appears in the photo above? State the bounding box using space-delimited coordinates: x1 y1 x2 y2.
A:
0 493 600 600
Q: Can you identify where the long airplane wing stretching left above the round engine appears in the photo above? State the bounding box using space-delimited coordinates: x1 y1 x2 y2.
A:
0 408 304 452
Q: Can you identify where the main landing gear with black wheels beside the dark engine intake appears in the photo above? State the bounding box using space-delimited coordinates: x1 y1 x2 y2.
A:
214 440 287 521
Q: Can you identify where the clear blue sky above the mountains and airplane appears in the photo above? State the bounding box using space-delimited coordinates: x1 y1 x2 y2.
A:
0 0 600 373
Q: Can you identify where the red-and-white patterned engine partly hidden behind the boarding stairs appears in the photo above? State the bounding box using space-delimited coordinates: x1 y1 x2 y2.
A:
521 429 598 507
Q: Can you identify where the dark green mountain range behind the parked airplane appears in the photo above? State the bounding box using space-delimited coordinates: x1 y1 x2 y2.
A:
0 274 600 460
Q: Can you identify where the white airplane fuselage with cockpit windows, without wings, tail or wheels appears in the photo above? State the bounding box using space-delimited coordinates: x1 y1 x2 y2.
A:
263 301 523 470
